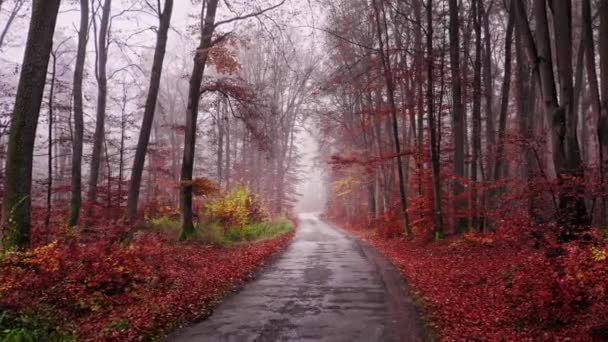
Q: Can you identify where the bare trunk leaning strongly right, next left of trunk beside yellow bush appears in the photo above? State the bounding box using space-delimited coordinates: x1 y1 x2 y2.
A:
126 0 173 220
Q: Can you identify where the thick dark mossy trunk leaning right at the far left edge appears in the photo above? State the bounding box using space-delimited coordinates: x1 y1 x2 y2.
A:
1 0 61 250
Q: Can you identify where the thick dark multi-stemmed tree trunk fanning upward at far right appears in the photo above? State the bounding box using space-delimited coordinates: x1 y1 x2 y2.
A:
515 0 589 236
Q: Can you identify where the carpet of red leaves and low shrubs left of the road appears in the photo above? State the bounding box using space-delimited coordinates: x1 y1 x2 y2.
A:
0 229 290 341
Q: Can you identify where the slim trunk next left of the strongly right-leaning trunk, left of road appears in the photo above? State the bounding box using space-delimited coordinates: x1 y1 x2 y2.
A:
87 0 112 224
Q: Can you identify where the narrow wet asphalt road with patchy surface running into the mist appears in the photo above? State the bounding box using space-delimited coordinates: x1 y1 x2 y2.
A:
168 214 426 342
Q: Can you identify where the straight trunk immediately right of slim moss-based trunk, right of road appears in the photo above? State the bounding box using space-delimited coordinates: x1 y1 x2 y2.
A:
448 0 467 232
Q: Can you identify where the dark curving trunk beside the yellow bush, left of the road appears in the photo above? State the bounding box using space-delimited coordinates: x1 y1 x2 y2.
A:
180 0 218 239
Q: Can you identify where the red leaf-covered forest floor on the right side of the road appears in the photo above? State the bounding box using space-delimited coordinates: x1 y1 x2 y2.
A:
339 222 608 341
